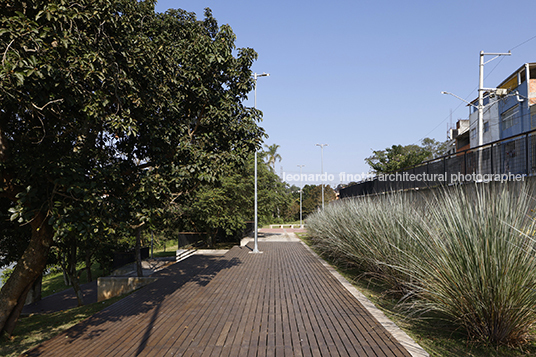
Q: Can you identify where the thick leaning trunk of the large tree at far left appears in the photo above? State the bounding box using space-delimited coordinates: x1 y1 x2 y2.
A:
0 212 54 335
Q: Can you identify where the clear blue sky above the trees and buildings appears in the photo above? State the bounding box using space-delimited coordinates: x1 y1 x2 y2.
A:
156 0 536 186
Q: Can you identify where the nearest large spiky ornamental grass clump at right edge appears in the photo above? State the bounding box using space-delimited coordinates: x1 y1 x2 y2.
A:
408 184 536 344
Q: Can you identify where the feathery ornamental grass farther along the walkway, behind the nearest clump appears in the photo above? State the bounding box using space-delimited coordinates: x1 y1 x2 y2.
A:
307 195 425 291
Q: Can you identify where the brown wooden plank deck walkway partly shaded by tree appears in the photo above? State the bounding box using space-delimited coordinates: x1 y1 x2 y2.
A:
25 236 418 357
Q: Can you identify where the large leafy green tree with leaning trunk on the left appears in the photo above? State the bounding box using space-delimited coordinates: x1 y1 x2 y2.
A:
0 0 263 334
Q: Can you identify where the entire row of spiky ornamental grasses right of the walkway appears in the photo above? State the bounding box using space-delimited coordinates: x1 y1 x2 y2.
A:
307 184 536 345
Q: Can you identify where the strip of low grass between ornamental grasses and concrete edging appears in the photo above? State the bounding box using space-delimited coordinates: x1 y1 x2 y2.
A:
295 233 536 357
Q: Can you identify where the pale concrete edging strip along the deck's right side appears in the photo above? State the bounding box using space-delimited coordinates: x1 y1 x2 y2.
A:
300 239 430 357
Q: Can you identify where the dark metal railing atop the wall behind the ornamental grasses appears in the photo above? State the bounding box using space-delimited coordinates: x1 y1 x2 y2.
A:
339 130 536 198
